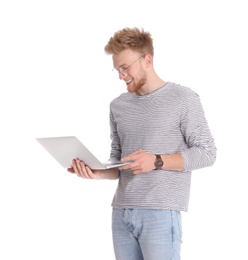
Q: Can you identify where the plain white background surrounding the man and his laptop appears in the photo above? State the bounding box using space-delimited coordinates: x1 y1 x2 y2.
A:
0 0 248 260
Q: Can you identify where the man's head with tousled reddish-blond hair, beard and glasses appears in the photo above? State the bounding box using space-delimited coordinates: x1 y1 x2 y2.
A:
104 28 154 93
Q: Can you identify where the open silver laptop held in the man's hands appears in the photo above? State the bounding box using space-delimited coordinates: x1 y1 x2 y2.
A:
36 136 131 170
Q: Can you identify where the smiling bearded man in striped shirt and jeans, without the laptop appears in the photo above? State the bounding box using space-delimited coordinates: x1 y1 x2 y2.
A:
68 28 216 260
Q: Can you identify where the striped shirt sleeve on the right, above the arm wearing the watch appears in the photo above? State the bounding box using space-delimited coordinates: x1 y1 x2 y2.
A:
181 91 216 171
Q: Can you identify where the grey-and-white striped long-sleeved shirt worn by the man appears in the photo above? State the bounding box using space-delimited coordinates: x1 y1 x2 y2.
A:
110 82 216 211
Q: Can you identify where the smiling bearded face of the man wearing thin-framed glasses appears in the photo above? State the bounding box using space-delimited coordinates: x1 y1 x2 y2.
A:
113 50 147 92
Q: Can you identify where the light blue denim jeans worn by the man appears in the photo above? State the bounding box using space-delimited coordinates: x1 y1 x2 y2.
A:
112 208 182 260
